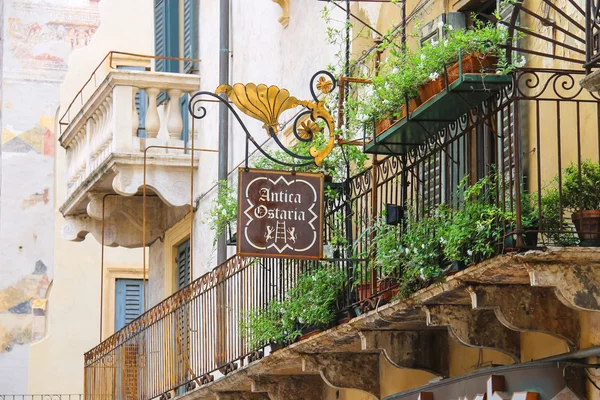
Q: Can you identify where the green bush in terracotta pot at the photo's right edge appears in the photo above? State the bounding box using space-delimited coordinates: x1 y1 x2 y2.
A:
561 160 600 246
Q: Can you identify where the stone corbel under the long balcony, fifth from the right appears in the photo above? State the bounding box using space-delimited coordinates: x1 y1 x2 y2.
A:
302 353 380 399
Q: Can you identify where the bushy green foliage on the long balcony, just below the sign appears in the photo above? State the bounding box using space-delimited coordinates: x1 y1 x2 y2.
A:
240 265 345 350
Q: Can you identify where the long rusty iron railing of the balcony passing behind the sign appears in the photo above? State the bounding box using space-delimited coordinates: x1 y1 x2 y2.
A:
85 69 600 400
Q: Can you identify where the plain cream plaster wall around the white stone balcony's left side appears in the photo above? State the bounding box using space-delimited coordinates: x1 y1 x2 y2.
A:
27 0 153 393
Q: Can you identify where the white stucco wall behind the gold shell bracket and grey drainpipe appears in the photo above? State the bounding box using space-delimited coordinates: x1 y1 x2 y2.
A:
194 1 344 277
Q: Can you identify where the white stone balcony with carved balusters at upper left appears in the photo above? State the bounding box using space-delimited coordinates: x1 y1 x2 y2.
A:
60 53 200 247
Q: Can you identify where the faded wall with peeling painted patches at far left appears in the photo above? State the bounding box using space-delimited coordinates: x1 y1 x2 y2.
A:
0 0 99 394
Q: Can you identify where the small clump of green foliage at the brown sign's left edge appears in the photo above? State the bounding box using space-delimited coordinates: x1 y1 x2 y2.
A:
205 181 238 246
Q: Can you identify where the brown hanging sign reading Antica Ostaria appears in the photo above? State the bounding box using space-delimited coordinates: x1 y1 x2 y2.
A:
237 168 323 258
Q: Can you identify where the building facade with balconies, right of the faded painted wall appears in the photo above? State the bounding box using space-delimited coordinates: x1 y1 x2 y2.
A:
3 0 600 400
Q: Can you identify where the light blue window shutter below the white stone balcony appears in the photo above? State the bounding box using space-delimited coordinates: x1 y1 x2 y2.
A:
115 279 148 332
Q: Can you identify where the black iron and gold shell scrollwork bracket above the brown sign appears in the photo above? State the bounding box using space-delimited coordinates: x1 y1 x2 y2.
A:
189 71 337 168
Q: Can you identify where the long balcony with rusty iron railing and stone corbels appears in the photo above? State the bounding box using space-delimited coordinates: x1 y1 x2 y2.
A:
85 70 600 400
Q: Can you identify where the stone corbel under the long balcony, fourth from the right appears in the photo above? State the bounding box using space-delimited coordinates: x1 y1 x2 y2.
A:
359 329 449 377
